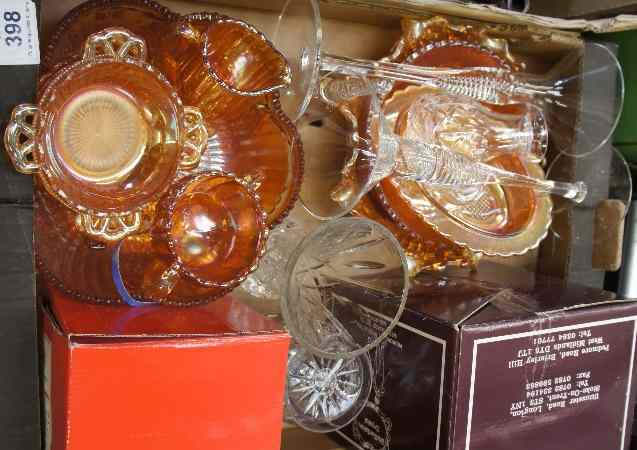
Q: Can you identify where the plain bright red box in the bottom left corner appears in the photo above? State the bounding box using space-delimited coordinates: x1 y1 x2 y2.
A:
39 283 289 450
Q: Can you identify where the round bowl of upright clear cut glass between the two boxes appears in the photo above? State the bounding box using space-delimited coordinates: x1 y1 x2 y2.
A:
281 218 409 359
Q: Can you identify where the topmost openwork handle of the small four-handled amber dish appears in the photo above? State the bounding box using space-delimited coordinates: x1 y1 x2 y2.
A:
82 28 146 61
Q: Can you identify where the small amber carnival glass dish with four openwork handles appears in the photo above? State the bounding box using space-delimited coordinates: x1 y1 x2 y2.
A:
5 28 208 241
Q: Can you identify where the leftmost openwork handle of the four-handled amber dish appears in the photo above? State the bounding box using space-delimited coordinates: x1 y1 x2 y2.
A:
4 104 39 174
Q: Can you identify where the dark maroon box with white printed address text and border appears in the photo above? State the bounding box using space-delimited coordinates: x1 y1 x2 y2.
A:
333 265 637 450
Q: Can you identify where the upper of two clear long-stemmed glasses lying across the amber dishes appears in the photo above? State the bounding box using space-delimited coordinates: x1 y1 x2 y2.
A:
273 0 624 159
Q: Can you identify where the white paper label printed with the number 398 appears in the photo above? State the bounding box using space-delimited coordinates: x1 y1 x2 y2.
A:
0 0 40 66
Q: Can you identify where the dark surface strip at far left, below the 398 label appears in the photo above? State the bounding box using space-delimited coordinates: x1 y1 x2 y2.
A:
0 0 40 450
